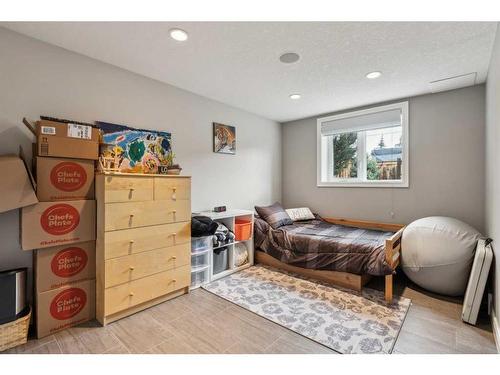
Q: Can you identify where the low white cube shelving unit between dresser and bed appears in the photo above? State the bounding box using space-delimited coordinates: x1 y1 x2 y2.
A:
191 210 254 289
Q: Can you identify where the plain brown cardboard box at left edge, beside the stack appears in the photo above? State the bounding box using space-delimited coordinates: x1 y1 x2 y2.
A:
0 155 38 212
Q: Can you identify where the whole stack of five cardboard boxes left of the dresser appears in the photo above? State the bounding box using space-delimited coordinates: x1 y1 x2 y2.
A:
21 120 99 338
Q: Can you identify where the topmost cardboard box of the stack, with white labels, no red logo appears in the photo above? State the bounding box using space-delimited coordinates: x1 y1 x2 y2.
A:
34 120 99 160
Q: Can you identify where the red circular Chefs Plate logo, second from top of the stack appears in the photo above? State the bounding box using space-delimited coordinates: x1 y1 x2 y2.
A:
40 203 80 236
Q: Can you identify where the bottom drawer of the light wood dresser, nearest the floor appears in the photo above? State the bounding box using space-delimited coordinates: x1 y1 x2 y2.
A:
104 266 191 316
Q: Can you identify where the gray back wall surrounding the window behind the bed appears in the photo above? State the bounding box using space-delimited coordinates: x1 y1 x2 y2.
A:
282 85 485 231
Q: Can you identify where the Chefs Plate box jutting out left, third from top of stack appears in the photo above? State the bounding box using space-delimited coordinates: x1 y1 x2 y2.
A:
21 201 96 250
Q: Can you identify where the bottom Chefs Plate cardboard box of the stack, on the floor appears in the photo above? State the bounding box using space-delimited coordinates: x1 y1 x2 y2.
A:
36 280 95 338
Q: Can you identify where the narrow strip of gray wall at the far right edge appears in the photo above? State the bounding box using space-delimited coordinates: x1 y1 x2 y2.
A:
486 28 500 339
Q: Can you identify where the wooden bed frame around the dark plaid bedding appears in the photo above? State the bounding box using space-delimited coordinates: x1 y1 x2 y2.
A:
255 217 405 303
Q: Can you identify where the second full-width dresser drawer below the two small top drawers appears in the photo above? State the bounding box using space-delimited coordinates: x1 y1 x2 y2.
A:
104 221 191 259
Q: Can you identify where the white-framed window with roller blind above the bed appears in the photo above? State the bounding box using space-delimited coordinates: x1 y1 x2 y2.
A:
317 102 409 187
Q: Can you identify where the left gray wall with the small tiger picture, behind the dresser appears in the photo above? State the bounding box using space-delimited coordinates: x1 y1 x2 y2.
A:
0 28 281 300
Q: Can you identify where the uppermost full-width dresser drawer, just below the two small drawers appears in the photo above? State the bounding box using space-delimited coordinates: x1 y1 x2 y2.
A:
104 200 191 231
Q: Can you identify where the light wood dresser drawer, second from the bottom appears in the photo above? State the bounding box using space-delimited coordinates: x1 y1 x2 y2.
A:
104 243 191 288
